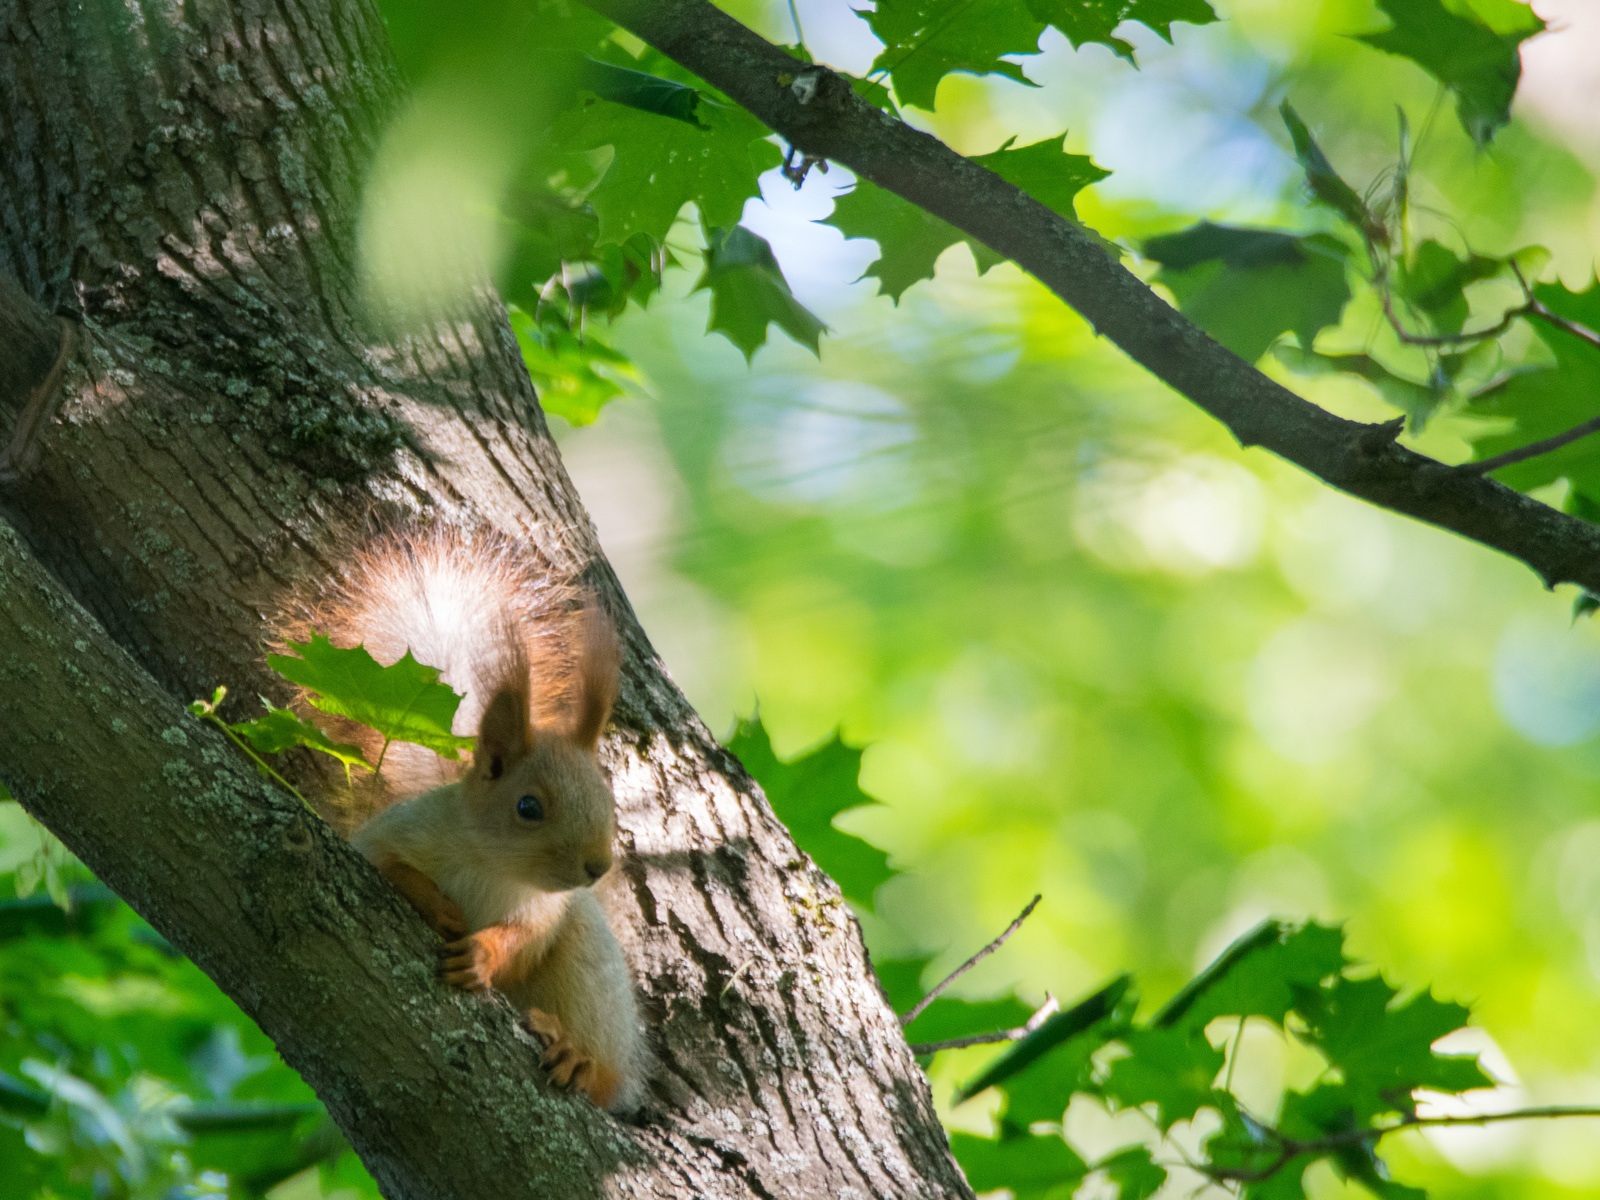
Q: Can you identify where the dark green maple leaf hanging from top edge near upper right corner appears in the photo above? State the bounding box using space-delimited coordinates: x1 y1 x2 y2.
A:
1360 0 1544 146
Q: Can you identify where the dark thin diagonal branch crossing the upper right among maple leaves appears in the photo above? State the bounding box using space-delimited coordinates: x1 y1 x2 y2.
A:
586 0 1600 590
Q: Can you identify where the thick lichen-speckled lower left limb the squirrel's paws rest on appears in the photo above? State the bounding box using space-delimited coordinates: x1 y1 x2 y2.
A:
0 522 656 1200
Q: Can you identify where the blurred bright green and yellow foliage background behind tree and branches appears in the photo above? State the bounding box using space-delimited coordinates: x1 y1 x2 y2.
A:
0 0 1600 1200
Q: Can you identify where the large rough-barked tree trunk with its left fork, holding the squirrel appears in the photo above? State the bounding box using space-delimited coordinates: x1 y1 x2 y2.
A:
0 0 971 1197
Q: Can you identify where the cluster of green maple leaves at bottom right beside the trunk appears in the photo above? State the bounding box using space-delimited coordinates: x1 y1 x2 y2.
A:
950 920 1494 1200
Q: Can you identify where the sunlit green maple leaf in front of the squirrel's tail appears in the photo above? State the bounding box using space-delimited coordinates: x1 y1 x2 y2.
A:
267 634 474 758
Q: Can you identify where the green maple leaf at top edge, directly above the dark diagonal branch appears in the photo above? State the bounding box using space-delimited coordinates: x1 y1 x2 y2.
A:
864 0 1045 112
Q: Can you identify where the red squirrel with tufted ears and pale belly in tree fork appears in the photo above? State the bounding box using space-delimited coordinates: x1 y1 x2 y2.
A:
280 531 650 1112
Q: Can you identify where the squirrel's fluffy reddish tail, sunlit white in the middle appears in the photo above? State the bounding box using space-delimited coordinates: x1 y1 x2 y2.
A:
272 526 598 819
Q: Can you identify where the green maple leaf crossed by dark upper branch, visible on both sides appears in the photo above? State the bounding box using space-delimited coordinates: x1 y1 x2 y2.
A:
822 133 1110 304
